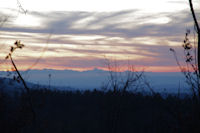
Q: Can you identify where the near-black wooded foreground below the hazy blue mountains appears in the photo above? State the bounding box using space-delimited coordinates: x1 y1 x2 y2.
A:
0 89 200 133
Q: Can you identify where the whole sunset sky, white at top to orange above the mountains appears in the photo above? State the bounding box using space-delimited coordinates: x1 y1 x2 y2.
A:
0 0 199 72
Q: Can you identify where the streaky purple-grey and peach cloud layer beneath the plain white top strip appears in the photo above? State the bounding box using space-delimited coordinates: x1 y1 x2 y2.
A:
0 10 193 71
